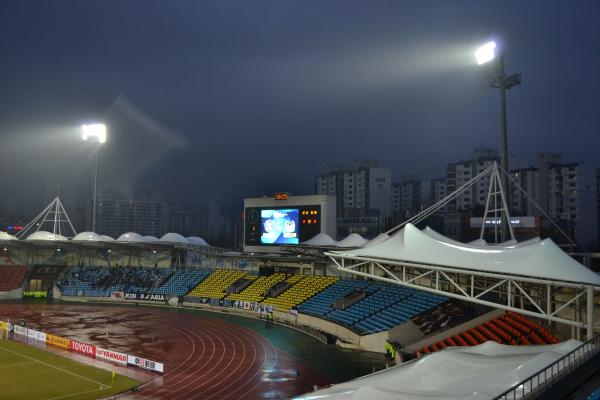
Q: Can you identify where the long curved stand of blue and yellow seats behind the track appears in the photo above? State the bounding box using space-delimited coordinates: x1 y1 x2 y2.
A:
59 267 447 333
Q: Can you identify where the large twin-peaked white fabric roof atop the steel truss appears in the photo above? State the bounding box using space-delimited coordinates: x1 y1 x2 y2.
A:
335 224 600 285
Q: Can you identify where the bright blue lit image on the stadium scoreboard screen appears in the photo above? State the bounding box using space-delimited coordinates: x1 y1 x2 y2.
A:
260 208 300 244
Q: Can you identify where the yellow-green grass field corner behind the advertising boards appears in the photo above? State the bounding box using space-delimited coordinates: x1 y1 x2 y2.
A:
0 339 140 400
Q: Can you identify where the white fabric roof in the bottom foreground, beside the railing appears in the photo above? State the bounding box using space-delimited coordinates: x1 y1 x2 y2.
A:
296 340 581 400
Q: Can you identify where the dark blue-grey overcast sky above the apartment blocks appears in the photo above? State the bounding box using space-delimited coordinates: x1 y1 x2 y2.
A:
0 0 600 216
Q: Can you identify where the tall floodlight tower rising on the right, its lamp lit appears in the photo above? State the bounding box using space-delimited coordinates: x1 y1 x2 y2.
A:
475 42 521 240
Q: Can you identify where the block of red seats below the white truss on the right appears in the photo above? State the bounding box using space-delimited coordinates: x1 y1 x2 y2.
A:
418 312 559 353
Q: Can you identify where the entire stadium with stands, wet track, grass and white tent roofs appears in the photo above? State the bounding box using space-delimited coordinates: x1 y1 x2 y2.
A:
0 184 600 399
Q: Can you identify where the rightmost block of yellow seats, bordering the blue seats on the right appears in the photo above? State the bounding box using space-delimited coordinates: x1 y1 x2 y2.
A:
264 275 339 312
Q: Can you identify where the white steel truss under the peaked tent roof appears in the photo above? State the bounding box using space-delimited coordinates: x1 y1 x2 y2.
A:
325 253 600 339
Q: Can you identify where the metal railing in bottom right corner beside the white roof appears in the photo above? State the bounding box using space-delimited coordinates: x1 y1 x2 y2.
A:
494 335 600 400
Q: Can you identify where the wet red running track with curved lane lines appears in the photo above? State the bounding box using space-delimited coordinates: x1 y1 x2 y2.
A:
0 304 333 400
